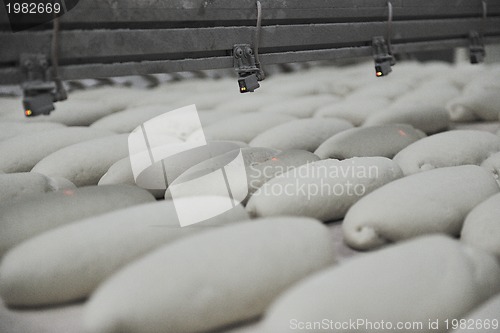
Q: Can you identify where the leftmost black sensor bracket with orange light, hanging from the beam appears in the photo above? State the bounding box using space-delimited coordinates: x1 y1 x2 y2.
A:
20 53 56 117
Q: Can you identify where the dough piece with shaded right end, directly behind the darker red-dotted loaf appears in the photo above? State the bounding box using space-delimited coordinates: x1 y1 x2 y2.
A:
363 103 450 134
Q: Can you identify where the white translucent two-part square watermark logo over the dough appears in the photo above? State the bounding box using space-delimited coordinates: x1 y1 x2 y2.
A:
128 105 248 226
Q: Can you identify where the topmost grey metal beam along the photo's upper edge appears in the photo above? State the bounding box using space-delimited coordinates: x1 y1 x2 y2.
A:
0 0 500 28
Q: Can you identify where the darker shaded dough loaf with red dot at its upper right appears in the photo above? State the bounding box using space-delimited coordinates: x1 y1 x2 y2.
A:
314 125 426 160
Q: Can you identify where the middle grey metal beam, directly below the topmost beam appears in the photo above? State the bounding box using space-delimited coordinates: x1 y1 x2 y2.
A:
0 18 500 64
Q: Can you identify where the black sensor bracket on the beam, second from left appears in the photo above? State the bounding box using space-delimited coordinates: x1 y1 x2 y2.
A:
233 44 262 93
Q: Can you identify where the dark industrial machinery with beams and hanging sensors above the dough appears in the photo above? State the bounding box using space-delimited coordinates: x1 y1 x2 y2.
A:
0 0 500 116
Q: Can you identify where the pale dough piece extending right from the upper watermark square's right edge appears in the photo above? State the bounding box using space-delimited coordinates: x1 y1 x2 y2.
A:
188 112 296 142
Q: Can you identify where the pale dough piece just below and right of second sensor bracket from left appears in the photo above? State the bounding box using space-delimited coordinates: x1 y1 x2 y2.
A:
259 94 339 118
